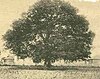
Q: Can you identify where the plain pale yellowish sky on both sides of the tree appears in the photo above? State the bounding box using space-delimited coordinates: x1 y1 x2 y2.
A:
0 0 100 57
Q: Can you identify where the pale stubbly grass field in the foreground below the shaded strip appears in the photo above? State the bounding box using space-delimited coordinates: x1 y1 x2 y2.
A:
0 67 100 79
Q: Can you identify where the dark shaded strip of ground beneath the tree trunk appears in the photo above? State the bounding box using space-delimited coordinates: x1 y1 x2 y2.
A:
6 65 100 70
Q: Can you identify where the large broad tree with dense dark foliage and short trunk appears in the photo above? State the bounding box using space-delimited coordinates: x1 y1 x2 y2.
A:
3 0 94 66
